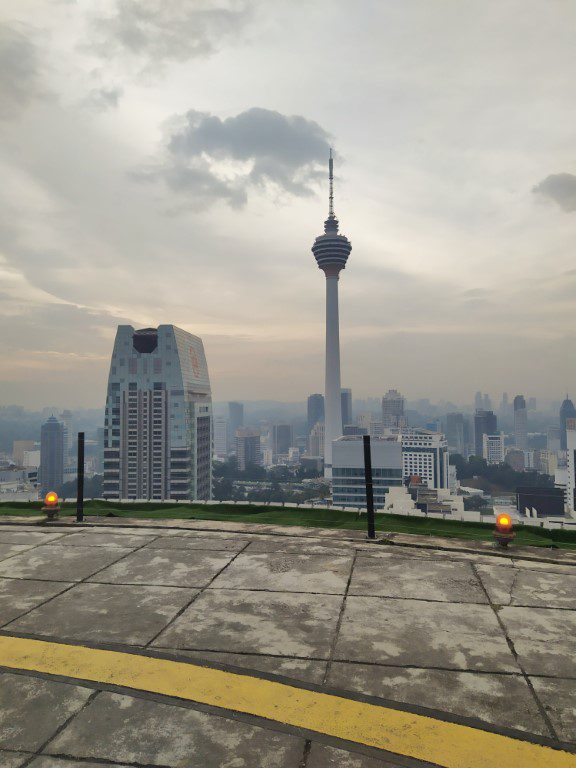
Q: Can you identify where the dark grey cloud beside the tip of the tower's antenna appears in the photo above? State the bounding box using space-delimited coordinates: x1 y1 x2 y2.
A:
139 107 329 207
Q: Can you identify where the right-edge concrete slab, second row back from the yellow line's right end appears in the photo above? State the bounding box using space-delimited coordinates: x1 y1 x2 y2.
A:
499 606 576 677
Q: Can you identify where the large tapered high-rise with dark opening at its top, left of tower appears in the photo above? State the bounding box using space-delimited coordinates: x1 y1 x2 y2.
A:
103 325 212 500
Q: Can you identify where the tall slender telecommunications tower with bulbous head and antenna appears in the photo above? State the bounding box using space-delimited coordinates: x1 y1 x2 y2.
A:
312 150 352 479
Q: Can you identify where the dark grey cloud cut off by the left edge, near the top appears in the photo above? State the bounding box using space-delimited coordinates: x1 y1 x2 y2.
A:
0 24 42 119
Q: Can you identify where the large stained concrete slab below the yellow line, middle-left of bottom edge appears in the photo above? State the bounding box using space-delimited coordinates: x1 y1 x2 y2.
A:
45 693 304 768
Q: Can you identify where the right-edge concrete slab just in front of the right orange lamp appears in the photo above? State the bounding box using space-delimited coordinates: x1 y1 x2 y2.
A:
478 565 576 610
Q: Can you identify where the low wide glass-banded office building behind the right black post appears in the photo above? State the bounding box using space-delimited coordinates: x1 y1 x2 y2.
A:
332 437 402 509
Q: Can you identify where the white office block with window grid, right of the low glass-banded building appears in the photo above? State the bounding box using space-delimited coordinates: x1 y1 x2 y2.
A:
400 429 449 488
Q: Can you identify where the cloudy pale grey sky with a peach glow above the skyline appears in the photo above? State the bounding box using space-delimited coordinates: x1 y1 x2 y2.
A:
0 0 576 408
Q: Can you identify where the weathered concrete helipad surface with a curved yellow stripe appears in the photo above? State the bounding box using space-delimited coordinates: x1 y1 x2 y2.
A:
0 521 576 768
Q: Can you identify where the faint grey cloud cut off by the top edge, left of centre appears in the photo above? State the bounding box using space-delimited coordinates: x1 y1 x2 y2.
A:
96 0 253 65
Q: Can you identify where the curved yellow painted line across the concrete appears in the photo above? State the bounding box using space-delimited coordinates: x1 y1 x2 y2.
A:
0 636 576 768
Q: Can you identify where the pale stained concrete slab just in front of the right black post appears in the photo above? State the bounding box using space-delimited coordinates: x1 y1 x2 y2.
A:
350 555 488 603
